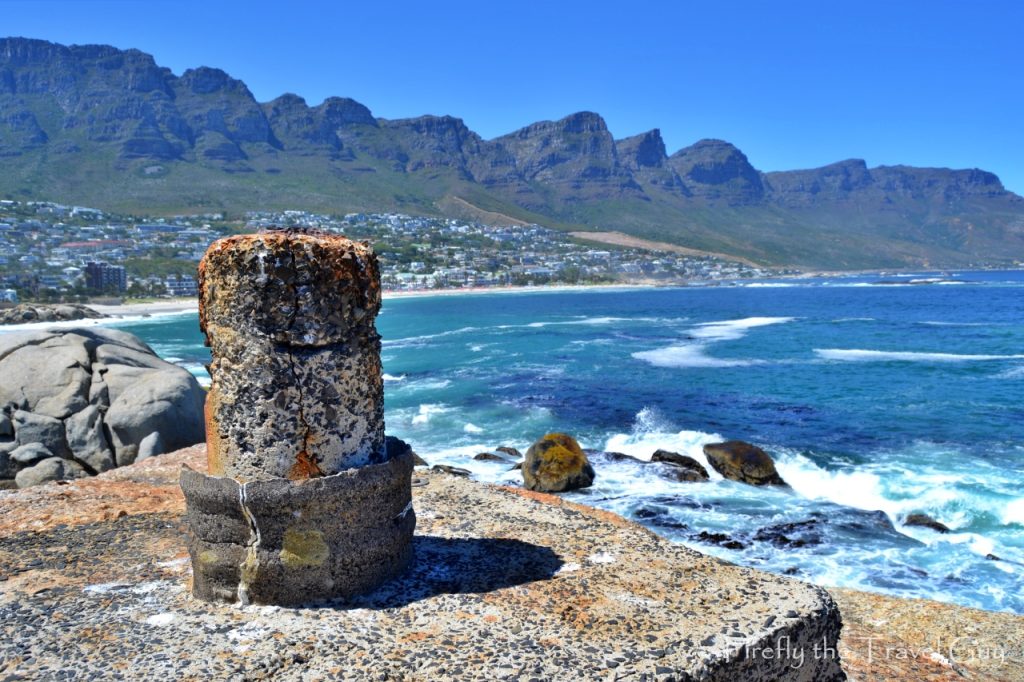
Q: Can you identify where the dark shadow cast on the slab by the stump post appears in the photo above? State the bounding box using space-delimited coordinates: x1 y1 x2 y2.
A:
344 536 562 608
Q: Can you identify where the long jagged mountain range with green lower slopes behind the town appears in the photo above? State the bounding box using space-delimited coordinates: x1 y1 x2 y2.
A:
0 38 1024 269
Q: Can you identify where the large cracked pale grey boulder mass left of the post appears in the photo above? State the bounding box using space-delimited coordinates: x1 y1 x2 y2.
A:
0 328 205 487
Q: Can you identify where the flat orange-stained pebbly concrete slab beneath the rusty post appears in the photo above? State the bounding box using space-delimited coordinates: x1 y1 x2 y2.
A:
0 445 1024 681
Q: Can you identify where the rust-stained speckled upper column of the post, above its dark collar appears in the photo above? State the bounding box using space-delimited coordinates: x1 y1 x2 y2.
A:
199 230 384 481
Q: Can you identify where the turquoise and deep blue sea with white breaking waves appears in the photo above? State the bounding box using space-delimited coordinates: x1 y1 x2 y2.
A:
44 272 1024 612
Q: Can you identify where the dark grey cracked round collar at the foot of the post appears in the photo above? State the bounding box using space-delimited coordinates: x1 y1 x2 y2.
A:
181 438 416 605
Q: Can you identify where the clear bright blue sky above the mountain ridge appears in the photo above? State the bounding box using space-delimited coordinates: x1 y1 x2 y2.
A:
6 0 1024 194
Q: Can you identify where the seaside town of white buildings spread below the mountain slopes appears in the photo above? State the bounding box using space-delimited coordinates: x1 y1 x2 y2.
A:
0 200 774 303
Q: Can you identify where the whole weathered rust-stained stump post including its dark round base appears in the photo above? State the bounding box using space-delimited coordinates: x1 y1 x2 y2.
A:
181 230 416 604
